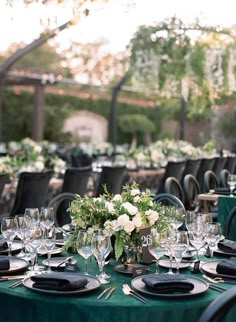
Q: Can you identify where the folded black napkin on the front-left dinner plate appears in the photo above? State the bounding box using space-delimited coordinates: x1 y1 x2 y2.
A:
31 272 88 291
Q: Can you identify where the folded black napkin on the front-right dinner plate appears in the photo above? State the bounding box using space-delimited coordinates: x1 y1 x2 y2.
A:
142 274 194 293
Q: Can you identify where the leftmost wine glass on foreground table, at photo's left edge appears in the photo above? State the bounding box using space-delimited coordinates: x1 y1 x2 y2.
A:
1 217 17 256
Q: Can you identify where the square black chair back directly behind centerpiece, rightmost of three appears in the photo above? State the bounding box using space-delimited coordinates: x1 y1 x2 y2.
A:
95 166 127 197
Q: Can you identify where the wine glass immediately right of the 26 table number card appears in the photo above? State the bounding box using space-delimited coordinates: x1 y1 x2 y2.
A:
148 228 165 274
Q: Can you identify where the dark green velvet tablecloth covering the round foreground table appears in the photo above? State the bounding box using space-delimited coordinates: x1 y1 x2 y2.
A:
0 252 236 322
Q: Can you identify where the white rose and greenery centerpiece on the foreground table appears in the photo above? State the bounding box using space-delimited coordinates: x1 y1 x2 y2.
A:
68 183 171 259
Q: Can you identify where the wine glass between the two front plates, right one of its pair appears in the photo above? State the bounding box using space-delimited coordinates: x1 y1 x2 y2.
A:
91 232 110 284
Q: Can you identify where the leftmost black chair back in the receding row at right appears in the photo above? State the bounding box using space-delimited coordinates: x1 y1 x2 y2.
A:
156 160 186 194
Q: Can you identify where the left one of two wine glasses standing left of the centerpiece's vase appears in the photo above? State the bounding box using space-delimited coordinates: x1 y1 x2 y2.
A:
76 230 92 275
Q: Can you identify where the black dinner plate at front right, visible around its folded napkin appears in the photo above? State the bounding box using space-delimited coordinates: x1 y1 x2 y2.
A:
131 274 208 298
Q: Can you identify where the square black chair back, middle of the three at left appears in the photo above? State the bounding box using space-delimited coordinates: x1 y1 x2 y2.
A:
61 166 92 197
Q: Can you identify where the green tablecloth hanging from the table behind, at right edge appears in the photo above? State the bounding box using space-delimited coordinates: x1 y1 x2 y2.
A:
217 196 236 241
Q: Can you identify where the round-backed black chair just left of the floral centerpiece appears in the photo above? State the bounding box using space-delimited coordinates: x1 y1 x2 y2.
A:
48 192 75 227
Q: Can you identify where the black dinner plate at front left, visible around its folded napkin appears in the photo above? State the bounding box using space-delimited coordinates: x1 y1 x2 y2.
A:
23 273 101 296
